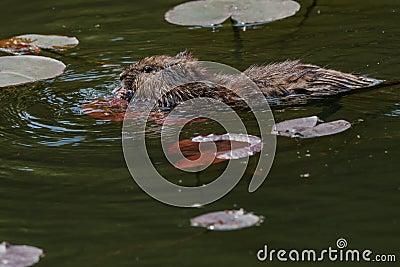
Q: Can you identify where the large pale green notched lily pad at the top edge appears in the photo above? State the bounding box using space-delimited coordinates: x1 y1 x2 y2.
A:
164 0 300 27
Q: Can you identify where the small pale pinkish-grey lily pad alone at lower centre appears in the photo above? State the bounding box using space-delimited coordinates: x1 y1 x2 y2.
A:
190 209 263 231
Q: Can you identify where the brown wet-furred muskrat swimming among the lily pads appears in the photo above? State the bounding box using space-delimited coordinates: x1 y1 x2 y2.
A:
113 51 384 108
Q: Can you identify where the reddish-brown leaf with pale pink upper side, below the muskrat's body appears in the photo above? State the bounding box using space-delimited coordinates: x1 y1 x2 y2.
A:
167 134 262 169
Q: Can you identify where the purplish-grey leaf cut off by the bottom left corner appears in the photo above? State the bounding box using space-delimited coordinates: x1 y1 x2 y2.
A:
0 242 43 267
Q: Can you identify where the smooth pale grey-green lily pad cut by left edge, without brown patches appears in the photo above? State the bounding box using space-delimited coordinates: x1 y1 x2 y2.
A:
0 55 65 87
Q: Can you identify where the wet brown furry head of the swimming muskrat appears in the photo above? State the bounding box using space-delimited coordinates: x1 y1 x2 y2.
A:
113 51 197 101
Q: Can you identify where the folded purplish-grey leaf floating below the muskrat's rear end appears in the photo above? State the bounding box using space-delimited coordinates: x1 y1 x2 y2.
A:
272 116 351 138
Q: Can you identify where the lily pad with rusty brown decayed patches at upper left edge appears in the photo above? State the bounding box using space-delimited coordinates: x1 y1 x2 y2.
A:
0 34 79 54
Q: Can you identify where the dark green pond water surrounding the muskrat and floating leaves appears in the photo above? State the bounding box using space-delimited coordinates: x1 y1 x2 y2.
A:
0 0 400 266
